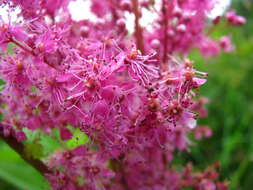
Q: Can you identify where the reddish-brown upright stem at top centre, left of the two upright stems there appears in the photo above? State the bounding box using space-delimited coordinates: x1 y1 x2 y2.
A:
131 0 145 53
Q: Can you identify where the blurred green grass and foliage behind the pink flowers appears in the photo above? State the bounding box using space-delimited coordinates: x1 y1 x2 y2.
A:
0 0 253 190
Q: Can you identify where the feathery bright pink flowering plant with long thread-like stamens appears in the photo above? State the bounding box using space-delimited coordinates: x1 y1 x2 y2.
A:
0 0 245 190
